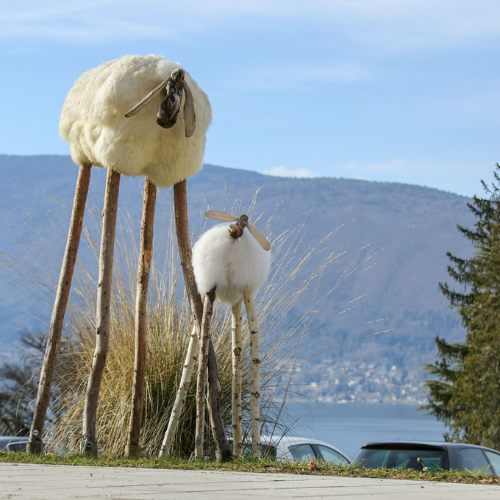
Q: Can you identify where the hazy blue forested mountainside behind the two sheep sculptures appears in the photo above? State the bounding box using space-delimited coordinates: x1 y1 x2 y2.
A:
0 155 480 400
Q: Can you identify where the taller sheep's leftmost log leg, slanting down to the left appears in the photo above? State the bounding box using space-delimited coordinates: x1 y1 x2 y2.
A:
27 165 92 453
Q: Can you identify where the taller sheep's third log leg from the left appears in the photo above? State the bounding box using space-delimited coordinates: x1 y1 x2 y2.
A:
125 177 156 457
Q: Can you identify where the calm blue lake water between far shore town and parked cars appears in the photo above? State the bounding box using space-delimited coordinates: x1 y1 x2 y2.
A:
280 403 445 459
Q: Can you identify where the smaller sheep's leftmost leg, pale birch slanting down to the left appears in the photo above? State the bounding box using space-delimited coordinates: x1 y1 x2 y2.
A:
160 326 200 457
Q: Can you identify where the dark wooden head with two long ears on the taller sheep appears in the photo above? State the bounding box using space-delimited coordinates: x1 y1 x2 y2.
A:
125 68 196 137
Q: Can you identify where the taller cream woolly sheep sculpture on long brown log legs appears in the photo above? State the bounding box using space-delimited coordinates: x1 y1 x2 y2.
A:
28 55 228 455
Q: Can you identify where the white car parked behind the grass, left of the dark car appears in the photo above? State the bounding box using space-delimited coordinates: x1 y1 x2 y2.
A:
239 436 351 465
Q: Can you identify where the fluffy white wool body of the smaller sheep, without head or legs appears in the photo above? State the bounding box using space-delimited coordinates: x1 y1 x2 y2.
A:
193 224 271 305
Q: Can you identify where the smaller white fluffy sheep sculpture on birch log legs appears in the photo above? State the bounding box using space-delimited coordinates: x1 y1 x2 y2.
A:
175 211 271 458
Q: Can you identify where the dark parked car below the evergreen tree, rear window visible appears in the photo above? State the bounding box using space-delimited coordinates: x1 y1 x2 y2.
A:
354 441 500 476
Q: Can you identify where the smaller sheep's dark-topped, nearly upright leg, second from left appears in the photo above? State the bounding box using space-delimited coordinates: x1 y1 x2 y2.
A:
194 287 215 460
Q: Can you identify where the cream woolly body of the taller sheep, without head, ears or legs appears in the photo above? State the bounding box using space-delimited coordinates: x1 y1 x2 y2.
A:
59 55 212 187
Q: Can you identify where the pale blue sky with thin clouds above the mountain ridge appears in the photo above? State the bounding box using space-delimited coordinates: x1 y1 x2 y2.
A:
0 0 500 196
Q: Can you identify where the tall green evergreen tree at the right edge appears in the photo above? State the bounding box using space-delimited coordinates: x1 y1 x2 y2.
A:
423 164 500 449
